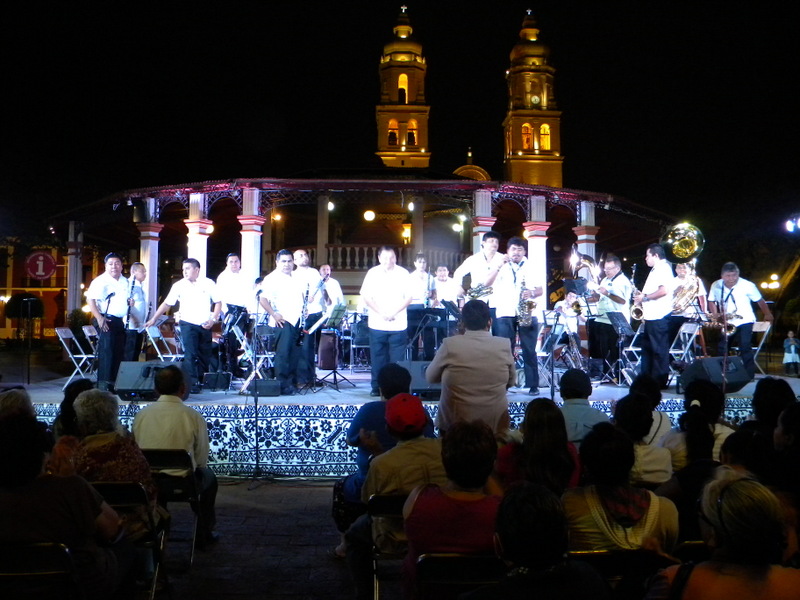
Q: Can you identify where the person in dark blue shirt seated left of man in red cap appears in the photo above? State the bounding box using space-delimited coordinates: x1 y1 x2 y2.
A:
332 363 434 558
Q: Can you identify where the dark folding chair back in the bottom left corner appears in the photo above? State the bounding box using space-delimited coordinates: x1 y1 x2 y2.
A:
0 543 85 600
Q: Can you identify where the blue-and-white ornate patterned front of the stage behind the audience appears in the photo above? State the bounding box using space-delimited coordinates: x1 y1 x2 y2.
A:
29 373 788 478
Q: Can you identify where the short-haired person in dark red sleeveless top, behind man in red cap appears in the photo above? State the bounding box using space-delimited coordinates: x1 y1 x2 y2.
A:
403 421 500 590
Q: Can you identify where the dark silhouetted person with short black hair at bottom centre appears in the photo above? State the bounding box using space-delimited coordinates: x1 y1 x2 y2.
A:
462 481 612 600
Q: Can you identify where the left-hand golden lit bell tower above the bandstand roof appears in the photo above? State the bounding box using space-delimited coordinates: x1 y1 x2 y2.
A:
375 6 430 168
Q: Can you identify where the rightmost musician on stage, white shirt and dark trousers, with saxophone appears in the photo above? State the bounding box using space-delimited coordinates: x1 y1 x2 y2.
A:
708 262 773 379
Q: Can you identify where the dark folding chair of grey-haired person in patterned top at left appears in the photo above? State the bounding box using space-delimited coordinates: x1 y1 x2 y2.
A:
92 481 166 600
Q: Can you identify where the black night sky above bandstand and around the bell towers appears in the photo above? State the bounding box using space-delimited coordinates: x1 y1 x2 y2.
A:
6 0 800 247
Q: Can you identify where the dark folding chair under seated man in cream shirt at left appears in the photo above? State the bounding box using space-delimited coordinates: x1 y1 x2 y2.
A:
142 448 200 567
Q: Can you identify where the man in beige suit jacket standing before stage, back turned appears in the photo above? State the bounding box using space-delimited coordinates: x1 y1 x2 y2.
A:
425 300 517 434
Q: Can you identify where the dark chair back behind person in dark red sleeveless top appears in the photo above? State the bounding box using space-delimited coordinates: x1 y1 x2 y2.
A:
417 553 506 600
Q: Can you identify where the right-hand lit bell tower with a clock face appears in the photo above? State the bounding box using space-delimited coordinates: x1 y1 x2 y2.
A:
503 11 564 187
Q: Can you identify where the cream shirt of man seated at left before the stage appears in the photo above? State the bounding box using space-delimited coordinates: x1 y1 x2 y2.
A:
133 396 208 475
